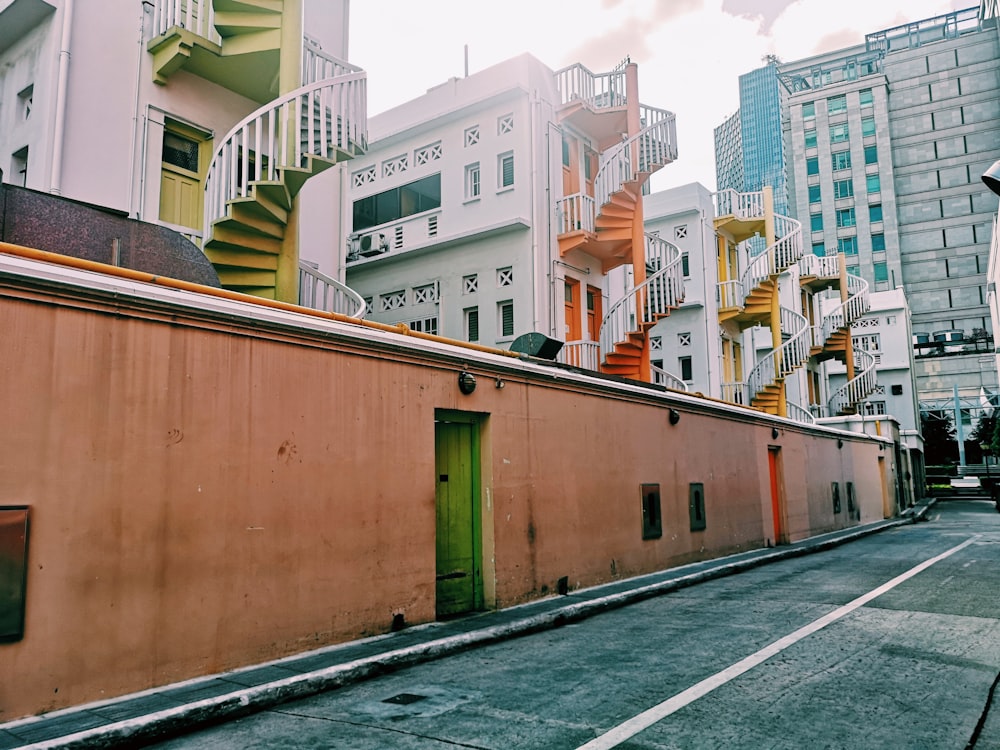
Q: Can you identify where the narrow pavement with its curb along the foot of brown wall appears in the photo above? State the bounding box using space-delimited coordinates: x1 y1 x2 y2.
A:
0 499 935 750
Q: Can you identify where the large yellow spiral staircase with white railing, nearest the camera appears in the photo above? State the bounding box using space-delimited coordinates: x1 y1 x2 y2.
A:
148 0 367 302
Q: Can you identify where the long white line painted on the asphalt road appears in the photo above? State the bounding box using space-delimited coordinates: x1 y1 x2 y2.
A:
577 535 978 750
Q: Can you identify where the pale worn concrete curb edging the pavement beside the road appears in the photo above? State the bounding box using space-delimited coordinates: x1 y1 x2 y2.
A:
9 516 934 750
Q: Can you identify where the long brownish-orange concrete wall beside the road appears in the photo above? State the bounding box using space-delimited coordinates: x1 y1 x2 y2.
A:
0 278 889 719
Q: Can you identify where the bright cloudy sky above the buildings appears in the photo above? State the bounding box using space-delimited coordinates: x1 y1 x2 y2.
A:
348 0 978 190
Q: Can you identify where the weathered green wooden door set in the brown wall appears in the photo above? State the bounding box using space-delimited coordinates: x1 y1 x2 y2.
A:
434 421 483 617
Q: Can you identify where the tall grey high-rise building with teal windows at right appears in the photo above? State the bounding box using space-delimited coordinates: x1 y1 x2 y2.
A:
717 2 1000 409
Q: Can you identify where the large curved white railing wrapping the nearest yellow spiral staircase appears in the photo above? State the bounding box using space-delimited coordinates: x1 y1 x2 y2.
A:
204 73 367 241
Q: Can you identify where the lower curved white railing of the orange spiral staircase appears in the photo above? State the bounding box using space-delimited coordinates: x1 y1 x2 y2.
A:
600 234 684 358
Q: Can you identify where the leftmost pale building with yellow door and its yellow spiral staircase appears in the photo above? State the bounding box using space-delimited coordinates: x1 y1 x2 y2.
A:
0 0 366 301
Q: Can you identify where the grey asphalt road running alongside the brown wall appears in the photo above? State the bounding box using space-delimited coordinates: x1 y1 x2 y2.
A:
148 500 1000 750
